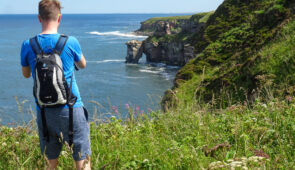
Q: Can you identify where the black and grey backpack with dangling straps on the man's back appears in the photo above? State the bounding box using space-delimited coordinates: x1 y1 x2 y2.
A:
30 35 77 146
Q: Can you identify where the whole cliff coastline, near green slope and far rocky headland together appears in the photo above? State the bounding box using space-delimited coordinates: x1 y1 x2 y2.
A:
128 0 295 109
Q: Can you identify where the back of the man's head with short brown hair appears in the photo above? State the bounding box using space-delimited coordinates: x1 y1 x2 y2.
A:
39 0 61 21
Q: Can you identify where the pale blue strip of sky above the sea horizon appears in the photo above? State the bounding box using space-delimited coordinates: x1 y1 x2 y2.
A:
0 0 223 14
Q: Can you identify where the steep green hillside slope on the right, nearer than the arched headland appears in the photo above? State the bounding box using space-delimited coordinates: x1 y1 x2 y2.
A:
162 0 295 108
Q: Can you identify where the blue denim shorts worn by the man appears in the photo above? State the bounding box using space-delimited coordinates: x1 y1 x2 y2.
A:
37 107 91 161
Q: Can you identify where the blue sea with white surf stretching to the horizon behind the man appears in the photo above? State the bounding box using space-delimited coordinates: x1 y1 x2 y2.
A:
0 14 186 125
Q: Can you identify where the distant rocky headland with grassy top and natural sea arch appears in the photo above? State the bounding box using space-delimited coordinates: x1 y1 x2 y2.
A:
126 12 213 66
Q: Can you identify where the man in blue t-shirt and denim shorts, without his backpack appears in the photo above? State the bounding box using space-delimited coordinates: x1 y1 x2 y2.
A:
21 0 91 169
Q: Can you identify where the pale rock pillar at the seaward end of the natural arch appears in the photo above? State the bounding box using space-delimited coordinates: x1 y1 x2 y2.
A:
126 40 143 64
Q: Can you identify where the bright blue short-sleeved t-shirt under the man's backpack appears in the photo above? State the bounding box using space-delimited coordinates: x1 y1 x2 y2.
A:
21 34 83 109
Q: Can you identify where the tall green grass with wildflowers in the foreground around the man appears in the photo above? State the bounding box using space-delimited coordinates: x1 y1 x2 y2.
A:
0 98 295 169
